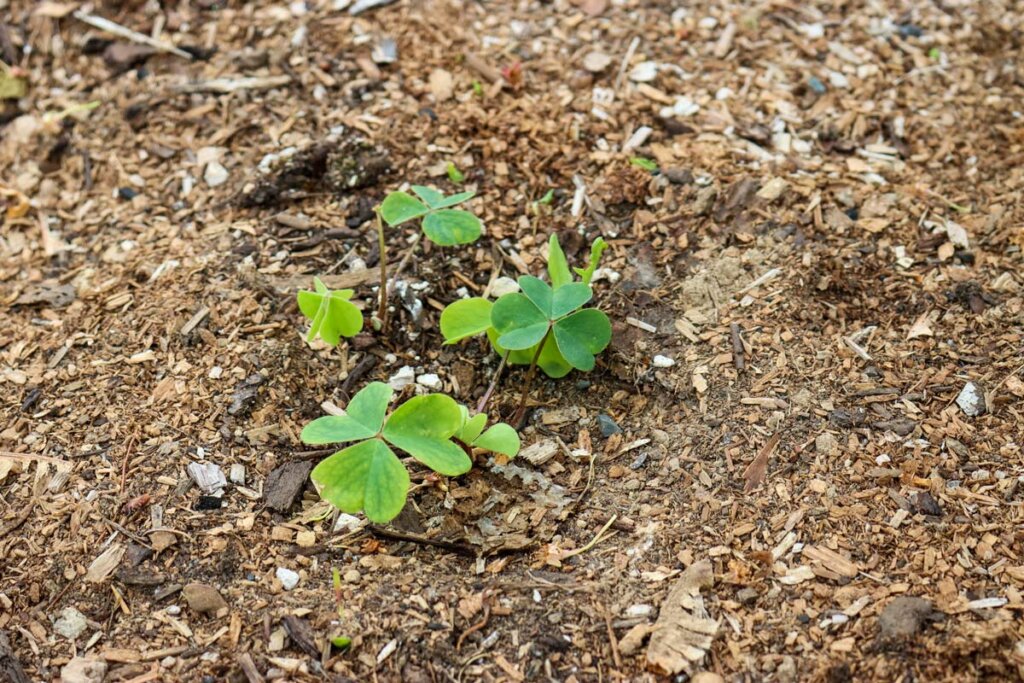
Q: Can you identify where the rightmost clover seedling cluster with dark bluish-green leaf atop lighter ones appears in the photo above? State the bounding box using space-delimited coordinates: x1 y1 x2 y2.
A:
440 236 611 417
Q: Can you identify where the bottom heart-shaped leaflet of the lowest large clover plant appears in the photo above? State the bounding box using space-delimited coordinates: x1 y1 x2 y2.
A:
310 438 409 523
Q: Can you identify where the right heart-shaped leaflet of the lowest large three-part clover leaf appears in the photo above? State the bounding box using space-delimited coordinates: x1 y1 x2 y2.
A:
382 393 473 476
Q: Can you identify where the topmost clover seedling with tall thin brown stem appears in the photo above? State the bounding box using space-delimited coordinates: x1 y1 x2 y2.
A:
377 184 483 330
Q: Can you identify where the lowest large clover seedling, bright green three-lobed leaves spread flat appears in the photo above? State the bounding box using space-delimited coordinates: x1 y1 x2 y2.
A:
302 382 519 523
